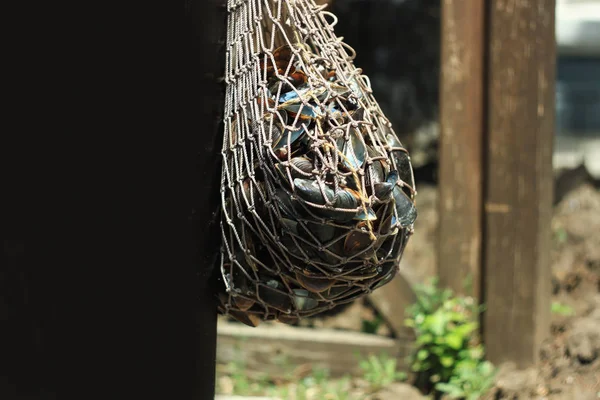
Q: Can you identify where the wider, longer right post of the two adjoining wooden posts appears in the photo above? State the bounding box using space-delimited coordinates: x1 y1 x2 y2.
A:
483 0 556 367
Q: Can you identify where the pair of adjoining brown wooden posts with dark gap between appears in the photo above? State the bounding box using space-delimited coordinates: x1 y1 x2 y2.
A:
438 0 556 367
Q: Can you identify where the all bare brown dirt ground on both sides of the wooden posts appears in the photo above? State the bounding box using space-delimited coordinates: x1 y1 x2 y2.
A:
307 183 600 400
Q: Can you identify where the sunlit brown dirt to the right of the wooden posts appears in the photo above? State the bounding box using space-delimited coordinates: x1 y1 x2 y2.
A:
490 184 600 400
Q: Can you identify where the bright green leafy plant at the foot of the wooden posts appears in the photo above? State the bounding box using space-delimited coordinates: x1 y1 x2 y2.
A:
405 279 493 399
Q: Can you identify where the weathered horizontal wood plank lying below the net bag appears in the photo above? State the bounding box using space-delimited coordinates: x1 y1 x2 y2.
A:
217 321 412 378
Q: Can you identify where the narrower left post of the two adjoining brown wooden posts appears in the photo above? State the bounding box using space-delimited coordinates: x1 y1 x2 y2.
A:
438 0 484 298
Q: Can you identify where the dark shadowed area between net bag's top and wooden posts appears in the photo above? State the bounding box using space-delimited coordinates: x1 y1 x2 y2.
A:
330 0 440 136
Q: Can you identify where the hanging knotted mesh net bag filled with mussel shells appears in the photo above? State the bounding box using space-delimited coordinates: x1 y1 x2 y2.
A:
218 0 417 326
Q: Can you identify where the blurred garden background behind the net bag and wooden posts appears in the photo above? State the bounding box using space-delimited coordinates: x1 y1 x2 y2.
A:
217 0 600 400
